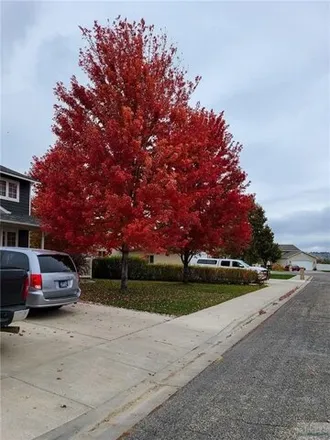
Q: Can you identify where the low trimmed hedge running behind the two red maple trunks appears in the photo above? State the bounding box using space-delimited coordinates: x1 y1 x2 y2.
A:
93 257 260 284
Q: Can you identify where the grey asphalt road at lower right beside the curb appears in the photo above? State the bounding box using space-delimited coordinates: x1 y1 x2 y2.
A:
123 274 330 440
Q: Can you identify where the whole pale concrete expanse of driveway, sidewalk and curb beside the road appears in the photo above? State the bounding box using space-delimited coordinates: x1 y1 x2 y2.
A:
1 279 310 440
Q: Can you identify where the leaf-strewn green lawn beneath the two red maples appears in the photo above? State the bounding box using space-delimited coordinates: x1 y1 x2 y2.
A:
81 280 262 316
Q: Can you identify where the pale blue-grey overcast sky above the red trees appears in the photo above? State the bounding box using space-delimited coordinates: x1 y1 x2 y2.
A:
1 1 330 251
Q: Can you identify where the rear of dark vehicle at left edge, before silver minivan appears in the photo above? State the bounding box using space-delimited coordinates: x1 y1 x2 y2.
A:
0 265 29 333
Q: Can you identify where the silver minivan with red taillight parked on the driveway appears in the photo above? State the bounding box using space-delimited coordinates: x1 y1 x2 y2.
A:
0 247 81 308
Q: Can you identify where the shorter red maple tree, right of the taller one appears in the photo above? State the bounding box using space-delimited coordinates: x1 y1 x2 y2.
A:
160 108 252 281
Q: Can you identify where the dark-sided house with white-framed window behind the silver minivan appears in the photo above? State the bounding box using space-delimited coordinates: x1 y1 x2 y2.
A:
0 165 39 247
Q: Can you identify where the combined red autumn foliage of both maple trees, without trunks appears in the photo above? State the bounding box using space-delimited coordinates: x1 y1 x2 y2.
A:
32 19 251 280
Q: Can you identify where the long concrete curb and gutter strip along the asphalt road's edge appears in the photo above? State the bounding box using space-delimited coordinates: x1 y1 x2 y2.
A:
35 277 312 440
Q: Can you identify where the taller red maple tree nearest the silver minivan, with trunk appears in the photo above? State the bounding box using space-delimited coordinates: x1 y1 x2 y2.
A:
32 18 199 289
